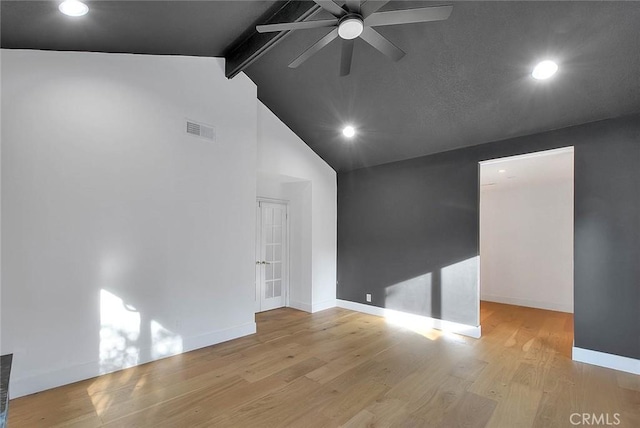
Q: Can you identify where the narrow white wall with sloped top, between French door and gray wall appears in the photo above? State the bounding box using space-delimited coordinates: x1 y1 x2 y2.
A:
258 102 337 312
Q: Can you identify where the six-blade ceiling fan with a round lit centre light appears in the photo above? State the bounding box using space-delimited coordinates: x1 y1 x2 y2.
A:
256 0 453 76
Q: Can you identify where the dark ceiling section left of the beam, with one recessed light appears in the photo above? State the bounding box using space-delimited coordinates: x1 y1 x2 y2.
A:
0 0 273 57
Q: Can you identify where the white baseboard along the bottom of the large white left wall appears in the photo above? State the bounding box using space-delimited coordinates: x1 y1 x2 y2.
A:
9 322 256 399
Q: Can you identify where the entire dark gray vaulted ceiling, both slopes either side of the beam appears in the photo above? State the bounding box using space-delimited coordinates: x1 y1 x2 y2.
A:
0 0 640 171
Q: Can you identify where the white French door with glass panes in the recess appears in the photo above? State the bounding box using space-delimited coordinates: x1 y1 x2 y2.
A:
256 201 288 312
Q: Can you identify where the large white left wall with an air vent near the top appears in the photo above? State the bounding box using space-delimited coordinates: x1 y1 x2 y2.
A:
1 50 260 397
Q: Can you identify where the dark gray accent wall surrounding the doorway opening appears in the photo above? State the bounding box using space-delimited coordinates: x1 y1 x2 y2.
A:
338 115 640 358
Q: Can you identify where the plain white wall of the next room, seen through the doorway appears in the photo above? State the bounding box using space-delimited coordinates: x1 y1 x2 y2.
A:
480 176 573 312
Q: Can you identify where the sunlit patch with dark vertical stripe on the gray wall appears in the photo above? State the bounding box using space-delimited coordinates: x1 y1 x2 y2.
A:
383 256 479 324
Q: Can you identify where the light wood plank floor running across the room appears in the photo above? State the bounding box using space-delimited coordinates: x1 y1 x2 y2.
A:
9 302 640 428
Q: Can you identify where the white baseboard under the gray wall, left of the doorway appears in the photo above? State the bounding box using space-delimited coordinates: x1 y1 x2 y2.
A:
337 299 482 339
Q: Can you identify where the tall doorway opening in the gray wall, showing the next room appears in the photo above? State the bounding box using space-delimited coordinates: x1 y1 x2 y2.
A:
479 147 574 357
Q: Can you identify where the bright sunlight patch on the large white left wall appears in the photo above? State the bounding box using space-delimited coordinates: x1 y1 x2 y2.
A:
100 289 182 374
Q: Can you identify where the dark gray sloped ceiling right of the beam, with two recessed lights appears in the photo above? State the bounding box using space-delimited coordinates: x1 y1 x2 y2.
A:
247 2 640 171
